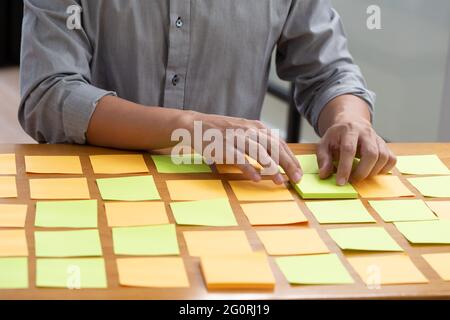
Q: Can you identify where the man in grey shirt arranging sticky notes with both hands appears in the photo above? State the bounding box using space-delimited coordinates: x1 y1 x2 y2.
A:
19 0 395 185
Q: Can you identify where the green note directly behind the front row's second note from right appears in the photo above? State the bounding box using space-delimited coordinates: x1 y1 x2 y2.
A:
328 227 403 251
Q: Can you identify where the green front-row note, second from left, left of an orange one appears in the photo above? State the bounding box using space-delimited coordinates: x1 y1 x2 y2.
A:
36 258 107 289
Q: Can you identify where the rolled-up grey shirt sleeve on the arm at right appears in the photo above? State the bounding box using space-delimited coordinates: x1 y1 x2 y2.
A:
276 0 375 133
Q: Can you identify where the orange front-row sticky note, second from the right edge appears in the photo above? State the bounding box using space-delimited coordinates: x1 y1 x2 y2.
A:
347 253 428 287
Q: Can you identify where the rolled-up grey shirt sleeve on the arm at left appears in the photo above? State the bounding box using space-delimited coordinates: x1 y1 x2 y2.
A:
19 0 115 144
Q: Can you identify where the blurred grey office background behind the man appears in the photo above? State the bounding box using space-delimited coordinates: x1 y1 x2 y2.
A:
0 0 450 143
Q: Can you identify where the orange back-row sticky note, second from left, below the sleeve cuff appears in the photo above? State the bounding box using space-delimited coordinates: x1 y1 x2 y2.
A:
25 156 83 174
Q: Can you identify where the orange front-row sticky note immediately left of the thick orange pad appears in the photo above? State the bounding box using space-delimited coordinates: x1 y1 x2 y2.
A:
117 257 189 288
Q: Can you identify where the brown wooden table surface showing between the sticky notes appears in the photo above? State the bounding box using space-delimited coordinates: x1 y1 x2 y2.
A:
0 144 450 299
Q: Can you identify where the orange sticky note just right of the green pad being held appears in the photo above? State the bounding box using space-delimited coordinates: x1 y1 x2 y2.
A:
353 175 414 198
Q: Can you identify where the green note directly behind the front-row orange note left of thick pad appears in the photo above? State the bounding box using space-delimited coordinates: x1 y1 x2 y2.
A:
112 224 180 256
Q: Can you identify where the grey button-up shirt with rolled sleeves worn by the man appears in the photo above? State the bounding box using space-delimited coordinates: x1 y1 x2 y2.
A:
19 0 374 143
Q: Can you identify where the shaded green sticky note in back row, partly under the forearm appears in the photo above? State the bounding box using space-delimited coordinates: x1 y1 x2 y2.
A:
152 153 212 173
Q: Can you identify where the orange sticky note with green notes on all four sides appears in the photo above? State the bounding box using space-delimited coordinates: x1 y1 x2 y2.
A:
105 201 169 227
